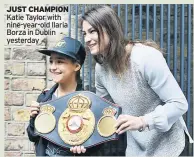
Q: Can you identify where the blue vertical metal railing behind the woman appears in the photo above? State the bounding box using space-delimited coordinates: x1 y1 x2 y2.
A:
68 4 193 156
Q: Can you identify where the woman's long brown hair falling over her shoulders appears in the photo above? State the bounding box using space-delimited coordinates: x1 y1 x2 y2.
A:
81 6 163 74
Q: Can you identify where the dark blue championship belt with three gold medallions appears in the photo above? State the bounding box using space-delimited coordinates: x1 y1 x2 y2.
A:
35 91 121 148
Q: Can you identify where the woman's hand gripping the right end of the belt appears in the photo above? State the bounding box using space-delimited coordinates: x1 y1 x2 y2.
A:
115 115 147 134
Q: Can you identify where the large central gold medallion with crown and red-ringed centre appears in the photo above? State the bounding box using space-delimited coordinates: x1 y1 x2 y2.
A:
58 94 95 145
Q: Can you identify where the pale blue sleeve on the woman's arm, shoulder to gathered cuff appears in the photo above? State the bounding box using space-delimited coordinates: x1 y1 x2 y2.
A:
140 47 188 132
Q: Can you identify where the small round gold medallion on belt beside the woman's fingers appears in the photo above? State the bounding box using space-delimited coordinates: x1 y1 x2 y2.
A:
97 107 116 137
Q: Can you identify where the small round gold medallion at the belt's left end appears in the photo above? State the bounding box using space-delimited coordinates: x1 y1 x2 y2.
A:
35 104 56 134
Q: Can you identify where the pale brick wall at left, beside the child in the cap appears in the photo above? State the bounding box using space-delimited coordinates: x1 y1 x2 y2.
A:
4 5 69 157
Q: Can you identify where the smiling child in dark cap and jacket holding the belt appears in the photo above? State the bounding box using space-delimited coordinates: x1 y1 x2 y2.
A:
27 37 93 156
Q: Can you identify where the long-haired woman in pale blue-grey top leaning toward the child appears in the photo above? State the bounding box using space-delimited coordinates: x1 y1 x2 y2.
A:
77 6 193 156
